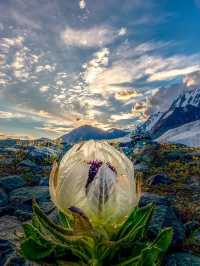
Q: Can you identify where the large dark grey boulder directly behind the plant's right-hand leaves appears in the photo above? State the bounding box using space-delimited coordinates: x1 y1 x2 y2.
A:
139 193 185 246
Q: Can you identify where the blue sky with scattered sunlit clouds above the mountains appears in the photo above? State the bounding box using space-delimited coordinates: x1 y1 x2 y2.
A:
0 0 200 138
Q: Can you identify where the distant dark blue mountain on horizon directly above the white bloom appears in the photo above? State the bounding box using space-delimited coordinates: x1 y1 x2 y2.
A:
58 125 129 144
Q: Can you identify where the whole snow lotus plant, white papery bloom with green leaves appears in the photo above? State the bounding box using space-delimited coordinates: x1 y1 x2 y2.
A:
21 141 173 266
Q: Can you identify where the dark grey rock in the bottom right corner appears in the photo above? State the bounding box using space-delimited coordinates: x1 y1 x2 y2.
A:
164 252 200 266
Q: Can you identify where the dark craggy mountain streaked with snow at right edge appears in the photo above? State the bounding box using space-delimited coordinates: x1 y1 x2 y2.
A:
148 88 200 137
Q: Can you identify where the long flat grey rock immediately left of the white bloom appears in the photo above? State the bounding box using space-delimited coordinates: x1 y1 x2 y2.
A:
9 186 49 204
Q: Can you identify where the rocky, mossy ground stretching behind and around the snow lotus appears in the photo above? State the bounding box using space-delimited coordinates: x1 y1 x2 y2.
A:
0 140 200 266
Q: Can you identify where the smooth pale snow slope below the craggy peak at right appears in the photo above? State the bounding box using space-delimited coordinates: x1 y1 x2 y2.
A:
156 120 200 147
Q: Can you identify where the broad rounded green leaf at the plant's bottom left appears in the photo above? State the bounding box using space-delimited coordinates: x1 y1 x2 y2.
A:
21 238 54 261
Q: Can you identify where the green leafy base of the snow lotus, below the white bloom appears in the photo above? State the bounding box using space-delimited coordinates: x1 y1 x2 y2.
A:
21 202 173 266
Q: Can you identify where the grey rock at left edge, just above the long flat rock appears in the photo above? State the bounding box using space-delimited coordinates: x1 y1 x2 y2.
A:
0 175 26 192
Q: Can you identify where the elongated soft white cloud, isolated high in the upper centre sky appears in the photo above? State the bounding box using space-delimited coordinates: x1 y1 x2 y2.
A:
61 26 118 48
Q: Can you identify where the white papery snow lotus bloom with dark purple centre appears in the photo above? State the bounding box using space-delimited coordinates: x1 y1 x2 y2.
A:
49 140 138 226
